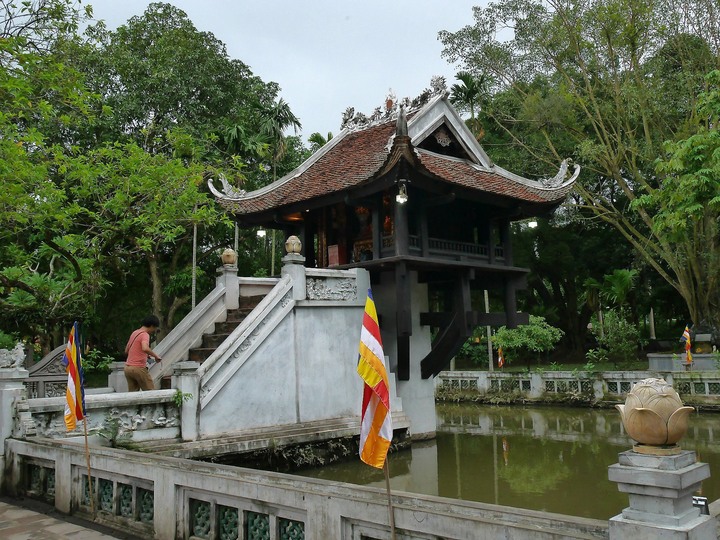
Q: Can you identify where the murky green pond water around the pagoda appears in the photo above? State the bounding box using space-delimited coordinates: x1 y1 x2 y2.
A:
295 404 720 519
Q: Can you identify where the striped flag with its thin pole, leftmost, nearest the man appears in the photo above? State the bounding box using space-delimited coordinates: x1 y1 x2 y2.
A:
62 321 95 515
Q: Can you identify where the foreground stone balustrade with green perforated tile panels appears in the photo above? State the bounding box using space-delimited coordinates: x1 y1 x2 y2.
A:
5 439 608 540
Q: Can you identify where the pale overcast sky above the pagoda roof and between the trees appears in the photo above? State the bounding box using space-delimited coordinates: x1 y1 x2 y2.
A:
86 0 484 140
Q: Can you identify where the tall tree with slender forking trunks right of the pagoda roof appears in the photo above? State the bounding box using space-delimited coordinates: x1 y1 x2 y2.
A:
440 0 720 324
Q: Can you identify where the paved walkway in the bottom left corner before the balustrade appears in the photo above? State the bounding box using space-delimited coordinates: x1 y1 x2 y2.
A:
0 497 134 540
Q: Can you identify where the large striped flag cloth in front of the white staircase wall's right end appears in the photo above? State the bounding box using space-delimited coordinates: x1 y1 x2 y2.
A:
357 289 393 469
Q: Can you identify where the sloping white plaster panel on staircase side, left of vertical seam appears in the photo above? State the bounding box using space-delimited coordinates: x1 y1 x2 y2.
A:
199 315 298 436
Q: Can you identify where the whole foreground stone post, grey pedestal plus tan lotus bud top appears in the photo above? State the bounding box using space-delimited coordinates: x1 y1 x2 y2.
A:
608 379 717 540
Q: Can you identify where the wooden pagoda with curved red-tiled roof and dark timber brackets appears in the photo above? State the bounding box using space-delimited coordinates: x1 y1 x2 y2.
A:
210 85 579 438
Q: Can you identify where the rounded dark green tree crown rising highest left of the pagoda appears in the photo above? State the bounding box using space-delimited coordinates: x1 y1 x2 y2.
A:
74 3 278 153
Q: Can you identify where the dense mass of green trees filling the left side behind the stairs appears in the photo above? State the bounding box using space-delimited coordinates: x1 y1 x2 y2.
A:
0 0 304 350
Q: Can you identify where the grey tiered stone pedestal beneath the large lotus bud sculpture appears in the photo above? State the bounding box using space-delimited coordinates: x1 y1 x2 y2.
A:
608 450 717 540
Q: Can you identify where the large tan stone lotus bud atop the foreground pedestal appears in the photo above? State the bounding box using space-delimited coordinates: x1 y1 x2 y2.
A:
615 379 695 446
